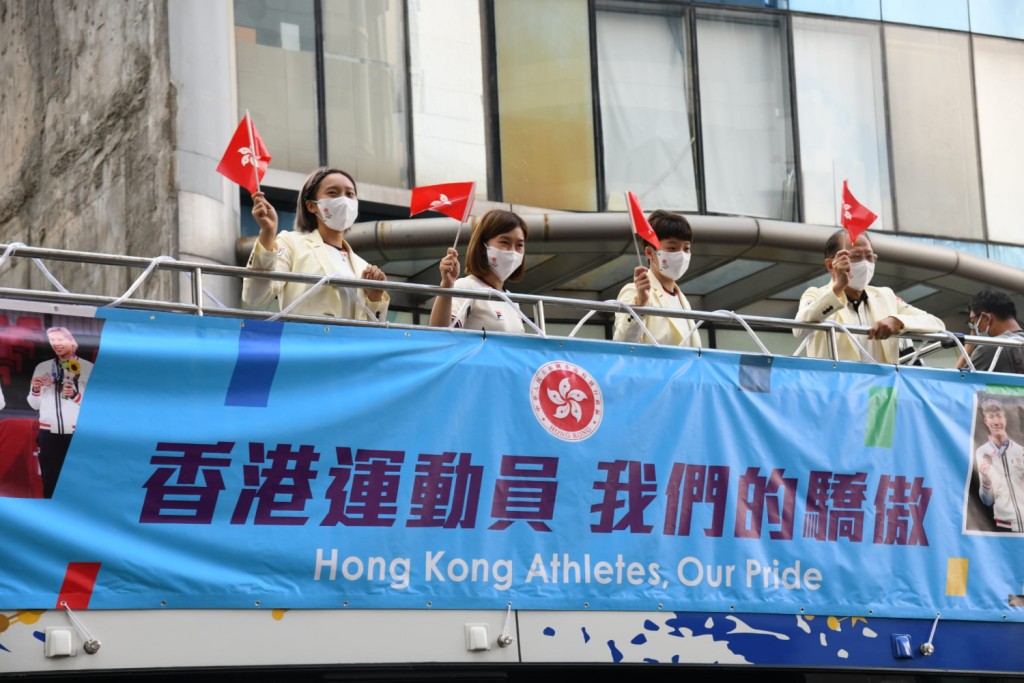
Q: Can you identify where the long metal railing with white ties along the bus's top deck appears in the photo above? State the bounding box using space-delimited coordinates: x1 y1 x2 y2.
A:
0 243 1011 371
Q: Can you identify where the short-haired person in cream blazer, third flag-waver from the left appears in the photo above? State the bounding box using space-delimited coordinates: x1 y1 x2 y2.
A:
612 210 700 348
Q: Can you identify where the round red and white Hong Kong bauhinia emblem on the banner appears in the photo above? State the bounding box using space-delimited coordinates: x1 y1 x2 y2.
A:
529 360 604 441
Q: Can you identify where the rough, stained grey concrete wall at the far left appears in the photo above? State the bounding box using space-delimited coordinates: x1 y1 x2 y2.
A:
0 0 178 297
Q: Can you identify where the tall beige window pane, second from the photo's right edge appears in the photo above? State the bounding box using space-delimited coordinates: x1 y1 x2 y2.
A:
884 26 983 239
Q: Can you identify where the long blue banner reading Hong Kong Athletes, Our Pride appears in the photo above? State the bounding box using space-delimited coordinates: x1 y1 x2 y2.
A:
0 310 1024 622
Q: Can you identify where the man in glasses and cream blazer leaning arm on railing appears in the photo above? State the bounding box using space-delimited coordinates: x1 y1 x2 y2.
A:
793 228 946 364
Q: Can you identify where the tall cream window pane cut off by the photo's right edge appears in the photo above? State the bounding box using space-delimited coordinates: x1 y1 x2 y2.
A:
974 37 1024 244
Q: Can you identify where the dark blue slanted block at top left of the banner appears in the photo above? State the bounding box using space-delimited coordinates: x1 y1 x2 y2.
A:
224 321 285 408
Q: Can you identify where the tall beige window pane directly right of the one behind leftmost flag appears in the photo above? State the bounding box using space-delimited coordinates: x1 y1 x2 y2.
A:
325 0 409 187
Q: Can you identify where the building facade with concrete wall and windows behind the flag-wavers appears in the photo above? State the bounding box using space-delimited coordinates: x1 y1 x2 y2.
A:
0 0 1024 356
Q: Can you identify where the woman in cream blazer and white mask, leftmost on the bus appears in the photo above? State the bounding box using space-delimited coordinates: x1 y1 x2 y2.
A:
242 168 390 321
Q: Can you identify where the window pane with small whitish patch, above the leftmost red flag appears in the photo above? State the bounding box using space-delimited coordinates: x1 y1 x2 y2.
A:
234 0 319 173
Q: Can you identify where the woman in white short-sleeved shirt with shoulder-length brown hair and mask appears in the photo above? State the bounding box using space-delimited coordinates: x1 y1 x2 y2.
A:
430 209 527 333
